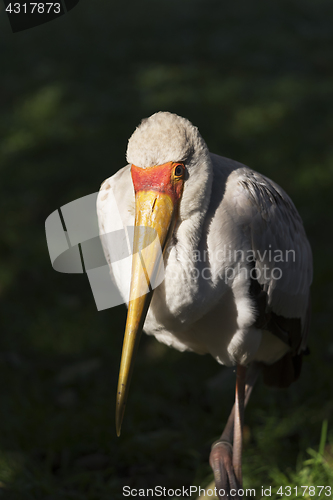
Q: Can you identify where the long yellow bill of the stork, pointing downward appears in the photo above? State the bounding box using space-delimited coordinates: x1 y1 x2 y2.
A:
116 191 175 436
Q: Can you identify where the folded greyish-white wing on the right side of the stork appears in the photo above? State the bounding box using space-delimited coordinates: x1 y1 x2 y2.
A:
220 167 312 352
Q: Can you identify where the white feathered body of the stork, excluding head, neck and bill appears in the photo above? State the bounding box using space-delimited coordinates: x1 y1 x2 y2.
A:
98 137 311 366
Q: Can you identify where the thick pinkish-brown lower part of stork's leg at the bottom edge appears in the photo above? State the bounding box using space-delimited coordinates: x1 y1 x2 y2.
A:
209 439 241 500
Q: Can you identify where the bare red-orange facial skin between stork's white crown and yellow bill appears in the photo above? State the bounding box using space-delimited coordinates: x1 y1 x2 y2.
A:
131 161 185 204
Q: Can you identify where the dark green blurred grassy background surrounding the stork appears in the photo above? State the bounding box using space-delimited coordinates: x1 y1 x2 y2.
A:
0 0 333 500
